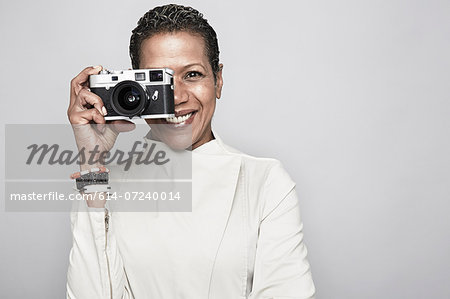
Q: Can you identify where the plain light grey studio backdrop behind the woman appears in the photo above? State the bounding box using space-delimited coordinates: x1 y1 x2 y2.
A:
0 0 450 299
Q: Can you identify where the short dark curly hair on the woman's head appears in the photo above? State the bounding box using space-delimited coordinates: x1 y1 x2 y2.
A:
130 4 220 77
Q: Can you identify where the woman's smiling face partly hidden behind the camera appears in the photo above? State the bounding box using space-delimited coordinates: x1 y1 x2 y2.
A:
139 32 223 149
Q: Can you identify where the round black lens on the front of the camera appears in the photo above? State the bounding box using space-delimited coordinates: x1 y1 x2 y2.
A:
111 81 148 117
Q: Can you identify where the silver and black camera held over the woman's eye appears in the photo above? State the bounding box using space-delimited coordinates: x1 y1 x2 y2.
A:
89 68 175 120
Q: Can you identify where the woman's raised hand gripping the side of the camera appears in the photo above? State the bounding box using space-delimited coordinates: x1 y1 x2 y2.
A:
67 66 135 170
